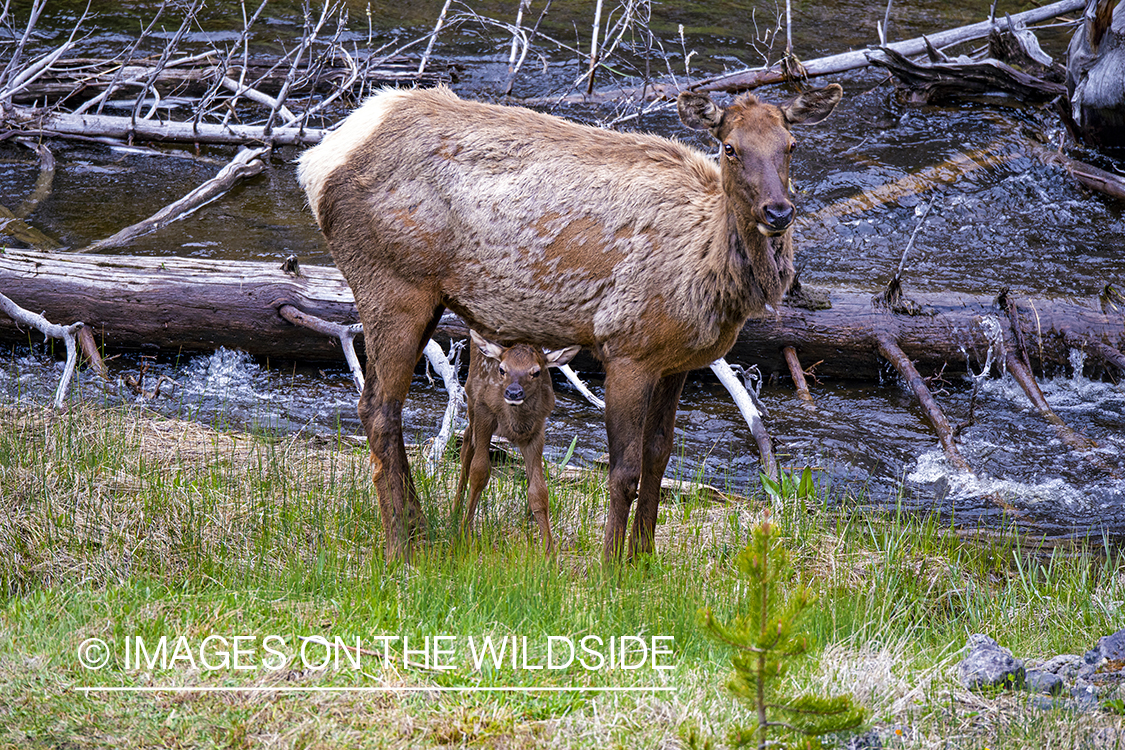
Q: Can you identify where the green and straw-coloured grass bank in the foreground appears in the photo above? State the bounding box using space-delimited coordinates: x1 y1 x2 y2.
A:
0 407 1125 750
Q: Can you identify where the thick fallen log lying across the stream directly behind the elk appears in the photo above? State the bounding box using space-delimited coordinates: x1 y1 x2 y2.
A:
0 250 1125 380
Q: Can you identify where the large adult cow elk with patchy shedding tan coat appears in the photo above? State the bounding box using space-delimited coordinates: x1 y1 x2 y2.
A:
298 84 842 560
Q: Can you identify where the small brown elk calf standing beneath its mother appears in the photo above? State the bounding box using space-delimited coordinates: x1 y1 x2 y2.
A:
453 331 578 554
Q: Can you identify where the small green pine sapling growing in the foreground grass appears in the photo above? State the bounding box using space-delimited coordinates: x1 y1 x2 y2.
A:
700 521 865 750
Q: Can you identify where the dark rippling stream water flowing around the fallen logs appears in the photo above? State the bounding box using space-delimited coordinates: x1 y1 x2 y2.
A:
0 1 1125 535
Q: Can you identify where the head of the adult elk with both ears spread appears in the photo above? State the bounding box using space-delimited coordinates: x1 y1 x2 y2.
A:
676 83 844 236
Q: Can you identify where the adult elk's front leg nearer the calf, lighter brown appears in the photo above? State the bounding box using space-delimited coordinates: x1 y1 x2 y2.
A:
603 361 656 562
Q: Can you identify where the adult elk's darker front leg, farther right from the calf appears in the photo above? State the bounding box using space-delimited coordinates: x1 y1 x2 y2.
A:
629 372 687 560
